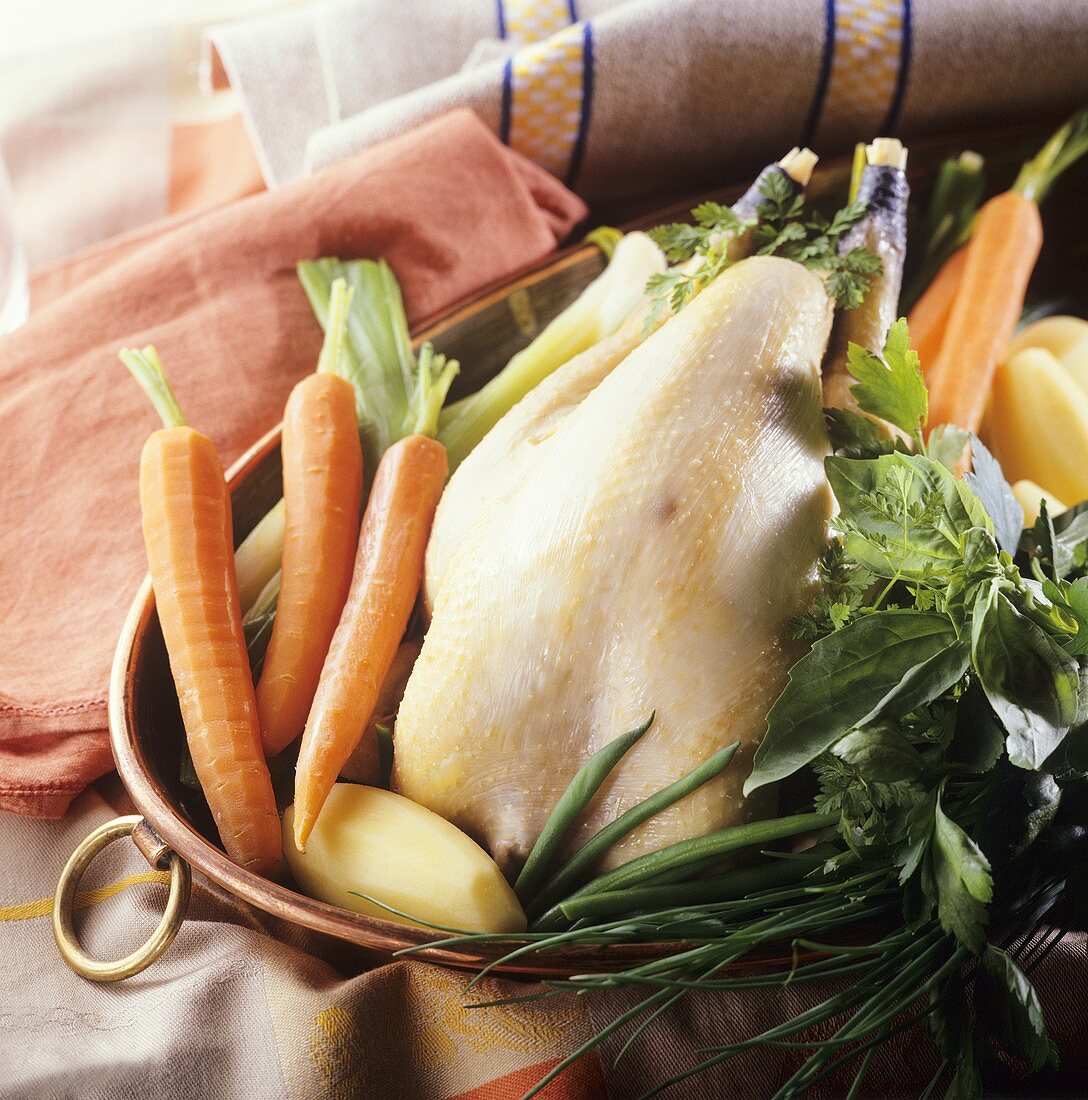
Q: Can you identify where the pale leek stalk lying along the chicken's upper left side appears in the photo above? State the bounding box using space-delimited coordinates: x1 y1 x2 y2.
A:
438 232 666 471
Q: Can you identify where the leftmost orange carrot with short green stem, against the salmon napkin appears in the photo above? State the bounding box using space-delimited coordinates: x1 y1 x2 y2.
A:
121 348 282 873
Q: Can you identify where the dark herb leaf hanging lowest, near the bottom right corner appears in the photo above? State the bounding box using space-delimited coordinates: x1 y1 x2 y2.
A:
975 944 1057 1073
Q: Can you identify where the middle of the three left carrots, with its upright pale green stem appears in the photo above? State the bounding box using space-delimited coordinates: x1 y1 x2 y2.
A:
256 279 363 756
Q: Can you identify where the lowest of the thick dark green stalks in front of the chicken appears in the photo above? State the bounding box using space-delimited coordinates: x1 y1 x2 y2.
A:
547 854 825 921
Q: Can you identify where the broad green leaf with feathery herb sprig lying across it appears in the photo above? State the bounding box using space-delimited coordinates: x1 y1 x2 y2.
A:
824 452 993 581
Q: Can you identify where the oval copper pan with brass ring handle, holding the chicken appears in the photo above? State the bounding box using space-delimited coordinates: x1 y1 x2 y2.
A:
54 121 1069 981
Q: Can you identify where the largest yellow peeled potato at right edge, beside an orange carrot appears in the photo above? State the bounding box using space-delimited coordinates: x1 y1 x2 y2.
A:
986 345 1088 507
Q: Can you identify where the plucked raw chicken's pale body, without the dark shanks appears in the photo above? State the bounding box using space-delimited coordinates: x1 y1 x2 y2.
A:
394 257 832 870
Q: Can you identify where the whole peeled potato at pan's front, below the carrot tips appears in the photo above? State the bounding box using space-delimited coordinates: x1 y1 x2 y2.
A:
283 783 525 932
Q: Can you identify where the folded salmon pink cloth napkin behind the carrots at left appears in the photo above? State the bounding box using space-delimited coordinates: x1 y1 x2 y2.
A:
0 110 585 816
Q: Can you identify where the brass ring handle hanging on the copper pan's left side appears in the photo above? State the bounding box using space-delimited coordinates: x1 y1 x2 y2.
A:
53 814 193 981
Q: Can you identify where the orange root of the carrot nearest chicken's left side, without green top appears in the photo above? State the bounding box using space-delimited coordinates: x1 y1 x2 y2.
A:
295 435 449 851
